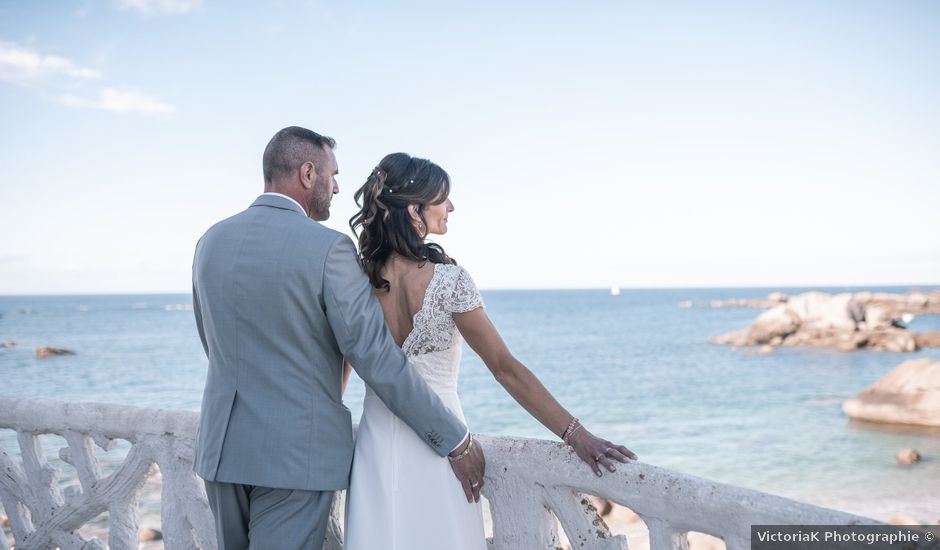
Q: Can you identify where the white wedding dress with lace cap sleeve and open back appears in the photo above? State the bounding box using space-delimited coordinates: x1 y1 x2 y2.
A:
345 264 487 550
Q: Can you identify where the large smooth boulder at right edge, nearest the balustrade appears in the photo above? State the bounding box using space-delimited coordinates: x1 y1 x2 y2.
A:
842 358 940 427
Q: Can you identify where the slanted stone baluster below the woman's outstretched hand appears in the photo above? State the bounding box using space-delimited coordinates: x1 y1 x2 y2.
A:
545 487 627 550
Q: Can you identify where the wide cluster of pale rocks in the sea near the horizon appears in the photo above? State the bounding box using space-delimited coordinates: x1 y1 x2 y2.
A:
709 292 940 351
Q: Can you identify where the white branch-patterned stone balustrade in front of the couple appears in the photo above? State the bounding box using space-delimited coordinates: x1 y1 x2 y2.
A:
0 397 875 550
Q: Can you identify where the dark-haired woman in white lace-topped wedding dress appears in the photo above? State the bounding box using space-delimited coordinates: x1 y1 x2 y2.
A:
345 153 636 550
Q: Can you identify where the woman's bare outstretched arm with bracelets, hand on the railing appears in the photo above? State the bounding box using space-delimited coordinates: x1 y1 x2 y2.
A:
454 308 636 476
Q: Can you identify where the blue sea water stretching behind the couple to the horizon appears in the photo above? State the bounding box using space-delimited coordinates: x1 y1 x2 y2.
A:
0 287 940 523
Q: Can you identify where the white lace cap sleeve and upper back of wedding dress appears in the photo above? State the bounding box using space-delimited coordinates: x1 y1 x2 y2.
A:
402 264 483 356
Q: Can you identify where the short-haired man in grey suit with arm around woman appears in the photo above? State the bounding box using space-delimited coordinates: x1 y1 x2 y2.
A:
193 127 484 550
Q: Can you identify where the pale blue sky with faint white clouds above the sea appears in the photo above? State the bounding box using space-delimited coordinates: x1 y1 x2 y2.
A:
0 0 940 295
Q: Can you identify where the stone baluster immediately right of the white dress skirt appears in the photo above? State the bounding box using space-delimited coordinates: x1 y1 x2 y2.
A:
483 484 561 550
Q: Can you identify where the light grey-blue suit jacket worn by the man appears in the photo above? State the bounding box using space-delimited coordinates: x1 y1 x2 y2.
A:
193 195 466 490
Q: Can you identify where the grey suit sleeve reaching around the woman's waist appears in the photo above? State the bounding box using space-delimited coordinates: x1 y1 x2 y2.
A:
323 235 467 456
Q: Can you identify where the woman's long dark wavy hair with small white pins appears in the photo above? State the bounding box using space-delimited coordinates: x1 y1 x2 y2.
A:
349 153 457 290
